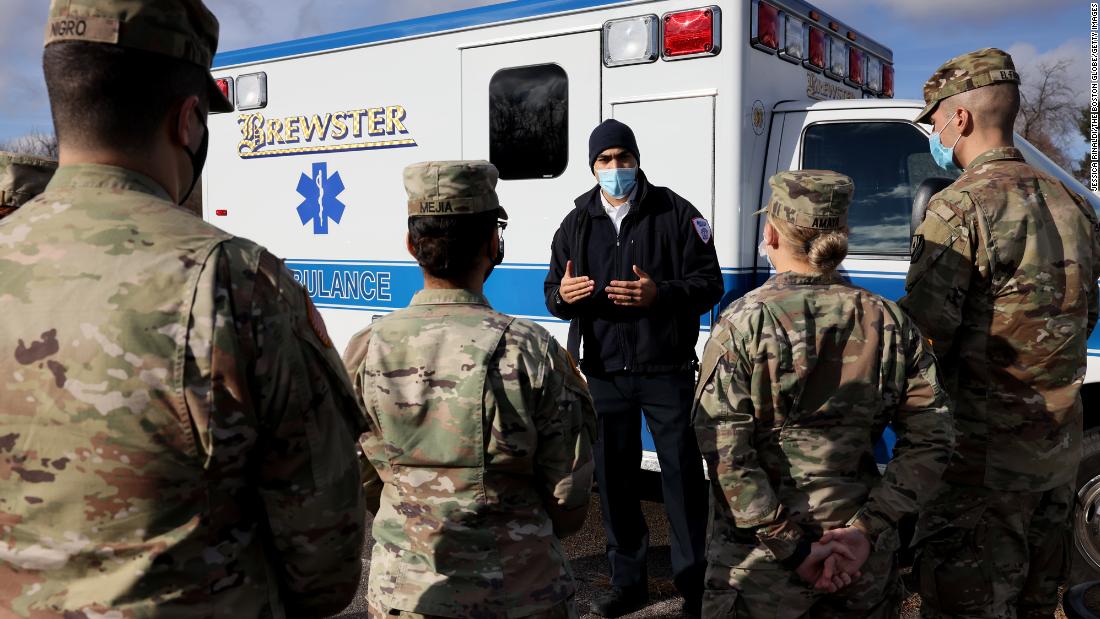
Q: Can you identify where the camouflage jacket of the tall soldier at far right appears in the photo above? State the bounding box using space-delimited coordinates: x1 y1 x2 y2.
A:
901 148 1100 491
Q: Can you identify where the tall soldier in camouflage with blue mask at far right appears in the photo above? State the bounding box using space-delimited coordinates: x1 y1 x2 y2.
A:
901 48 1100 617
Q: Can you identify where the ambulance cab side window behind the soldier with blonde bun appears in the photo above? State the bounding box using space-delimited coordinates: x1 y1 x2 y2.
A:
802 121 955 256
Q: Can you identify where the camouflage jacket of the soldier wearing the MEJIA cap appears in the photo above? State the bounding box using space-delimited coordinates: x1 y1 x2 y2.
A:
344 290 595 619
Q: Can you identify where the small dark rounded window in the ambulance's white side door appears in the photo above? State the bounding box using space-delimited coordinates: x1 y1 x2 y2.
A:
488 65 569 180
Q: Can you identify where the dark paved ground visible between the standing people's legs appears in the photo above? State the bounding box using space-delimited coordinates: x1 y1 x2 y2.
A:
334 495 1066 619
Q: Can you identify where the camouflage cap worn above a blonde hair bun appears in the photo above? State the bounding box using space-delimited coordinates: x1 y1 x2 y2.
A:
756 169 856 230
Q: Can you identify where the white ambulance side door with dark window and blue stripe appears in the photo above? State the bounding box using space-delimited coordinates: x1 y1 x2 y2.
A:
462 31 602 325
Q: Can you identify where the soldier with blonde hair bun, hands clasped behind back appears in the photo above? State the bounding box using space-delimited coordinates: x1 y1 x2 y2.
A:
694 170 954 619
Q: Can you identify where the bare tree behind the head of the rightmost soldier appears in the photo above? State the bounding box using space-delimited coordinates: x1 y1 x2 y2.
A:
1016 59 1080 172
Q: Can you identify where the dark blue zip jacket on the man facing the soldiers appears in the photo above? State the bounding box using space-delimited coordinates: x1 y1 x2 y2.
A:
543 172 723 374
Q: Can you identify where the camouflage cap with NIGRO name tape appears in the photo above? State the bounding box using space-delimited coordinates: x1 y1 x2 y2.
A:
45 0 233 112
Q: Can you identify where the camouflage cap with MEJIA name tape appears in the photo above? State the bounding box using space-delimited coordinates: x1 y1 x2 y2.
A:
405 161 508 219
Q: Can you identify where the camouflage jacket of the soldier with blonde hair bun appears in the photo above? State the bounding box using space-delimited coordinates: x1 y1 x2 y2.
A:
693 273 954 578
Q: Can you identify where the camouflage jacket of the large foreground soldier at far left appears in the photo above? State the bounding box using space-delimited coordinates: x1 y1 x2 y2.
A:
0 165 365 619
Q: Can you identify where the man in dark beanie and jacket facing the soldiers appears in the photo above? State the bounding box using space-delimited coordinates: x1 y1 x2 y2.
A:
545 120 723 617
